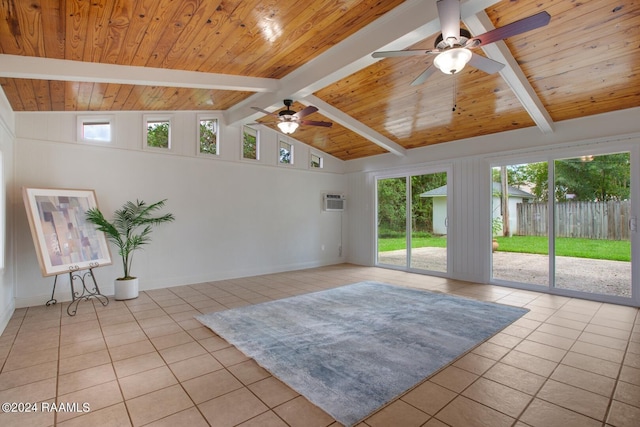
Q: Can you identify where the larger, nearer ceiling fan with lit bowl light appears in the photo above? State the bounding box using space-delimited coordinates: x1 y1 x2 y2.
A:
372 0 551 86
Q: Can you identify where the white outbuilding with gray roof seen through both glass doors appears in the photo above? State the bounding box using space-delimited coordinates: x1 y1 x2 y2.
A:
420 182 535 234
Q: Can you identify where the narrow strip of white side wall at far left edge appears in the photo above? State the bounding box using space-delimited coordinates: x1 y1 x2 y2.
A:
0 89 15 333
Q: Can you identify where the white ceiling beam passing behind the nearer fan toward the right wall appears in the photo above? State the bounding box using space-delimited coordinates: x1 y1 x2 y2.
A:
463 11 553 134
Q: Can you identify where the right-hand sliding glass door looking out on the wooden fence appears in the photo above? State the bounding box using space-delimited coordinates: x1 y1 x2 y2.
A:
491 152 637 301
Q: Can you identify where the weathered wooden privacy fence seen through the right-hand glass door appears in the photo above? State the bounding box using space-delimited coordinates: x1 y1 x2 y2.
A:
515 200 631 240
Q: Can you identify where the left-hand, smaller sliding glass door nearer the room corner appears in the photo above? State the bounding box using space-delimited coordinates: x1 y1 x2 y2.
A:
377 172 448 273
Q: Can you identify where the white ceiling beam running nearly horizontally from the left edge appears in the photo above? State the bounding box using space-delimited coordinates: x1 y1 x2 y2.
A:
0 54 279 92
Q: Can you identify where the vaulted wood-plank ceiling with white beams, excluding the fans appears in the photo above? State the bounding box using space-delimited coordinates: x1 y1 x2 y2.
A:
0 0 640 160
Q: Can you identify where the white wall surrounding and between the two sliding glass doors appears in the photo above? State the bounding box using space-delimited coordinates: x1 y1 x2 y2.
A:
346 108 640 283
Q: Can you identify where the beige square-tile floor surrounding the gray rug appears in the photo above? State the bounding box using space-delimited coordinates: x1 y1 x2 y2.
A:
0 265 640 427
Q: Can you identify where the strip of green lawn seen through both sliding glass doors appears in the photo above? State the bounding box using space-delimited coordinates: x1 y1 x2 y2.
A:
378 236 631 261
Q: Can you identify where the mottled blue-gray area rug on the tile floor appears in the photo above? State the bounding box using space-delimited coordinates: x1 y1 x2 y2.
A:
196 282 528 426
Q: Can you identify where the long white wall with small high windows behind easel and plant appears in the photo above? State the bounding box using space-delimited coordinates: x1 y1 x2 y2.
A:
14 112 347 307
